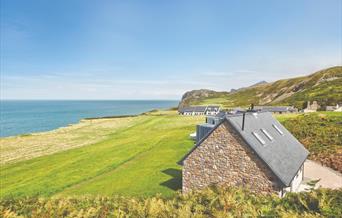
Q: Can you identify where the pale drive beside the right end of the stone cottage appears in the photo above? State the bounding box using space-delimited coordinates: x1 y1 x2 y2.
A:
304 160 342 189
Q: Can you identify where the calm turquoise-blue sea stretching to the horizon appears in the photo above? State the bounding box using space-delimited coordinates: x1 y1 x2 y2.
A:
0 100 178 137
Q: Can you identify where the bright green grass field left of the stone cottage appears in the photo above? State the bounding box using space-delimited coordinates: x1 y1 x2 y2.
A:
0 112 203 197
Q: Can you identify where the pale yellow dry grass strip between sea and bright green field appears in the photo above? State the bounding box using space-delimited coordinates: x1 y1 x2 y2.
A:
0 117 141 165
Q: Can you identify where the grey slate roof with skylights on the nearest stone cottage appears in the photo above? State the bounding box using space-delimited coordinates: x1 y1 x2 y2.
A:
180 112 309 186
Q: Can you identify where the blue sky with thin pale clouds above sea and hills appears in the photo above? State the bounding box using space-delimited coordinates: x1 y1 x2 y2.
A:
0 0 342 99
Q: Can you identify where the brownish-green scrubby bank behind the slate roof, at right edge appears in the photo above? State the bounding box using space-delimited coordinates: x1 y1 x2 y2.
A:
278 112 342 173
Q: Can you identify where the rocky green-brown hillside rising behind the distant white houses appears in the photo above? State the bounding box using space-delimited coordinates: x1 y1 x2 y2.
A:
179 66 342 109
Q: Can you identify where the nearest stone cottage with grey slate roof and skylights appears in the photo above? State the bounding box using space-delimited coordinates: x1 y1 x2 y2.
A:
180 112 309 196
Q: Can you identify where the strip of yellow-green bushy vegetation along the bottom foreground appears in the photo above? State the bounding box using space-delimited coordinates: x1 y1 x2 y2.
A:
0 188 342 217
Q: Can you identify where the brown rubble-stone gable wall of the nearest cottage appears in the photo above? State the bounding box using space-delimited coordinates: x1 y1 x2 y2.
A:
183 122 280 193
